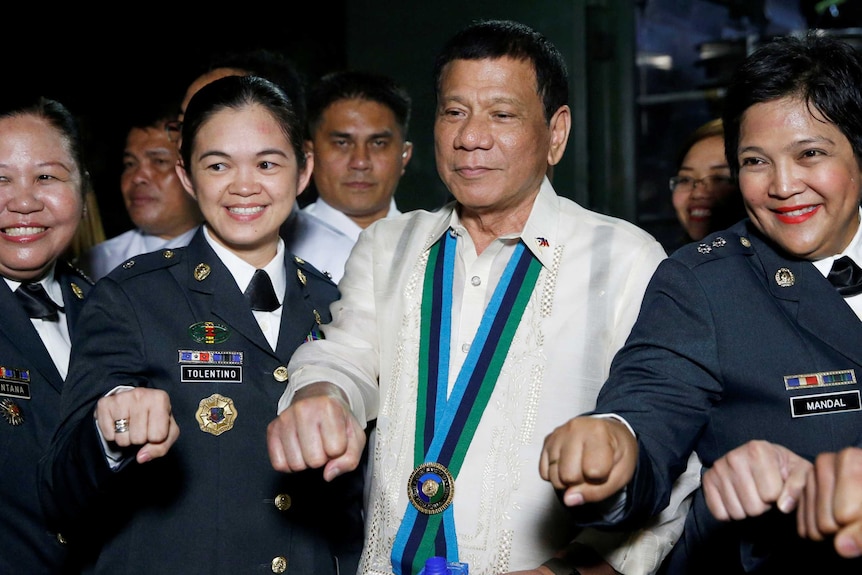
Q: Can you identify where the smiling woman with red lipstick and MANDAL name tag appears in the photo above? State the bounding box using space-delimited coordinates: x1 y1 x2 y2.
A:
541 32 862 575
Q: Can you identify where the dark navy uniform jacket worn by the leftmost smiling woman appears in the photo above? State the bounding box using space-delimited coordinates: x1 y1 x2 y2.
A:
0 262 92 574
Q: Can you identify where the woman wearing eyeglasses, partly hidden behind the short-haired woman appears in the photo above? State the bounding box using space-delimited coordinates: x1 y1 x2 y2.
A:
669 118 745 251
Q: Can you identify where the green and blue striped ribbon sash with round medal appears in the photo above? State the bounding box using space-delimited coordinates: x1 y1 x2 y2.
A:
391 231 542 575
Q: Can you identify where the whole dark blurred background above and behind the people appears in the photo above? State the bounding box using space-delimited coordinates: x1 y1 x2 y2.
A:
5 0 862 250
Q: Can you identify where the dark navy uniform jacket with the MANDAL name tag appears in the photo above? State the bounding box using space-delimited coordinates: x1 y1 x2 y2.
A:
584 220 862 574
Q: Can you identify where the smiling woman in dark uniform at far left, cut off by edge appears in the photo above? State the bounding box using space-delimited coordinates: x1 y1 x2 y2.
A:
0 94 91 573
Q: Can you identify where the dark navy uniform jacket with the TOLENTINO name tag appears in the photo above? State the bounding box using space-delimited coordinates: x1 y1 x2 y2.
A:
42 231 362 575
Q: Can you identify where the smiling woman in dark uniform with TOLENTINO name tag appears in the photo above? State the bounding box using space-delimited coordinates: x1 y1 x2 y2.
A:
42 76 361 574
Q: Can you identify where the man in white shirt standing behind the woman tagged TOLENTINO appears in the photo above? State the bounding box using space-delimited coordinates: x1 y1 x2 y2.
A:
299 70 413 283
